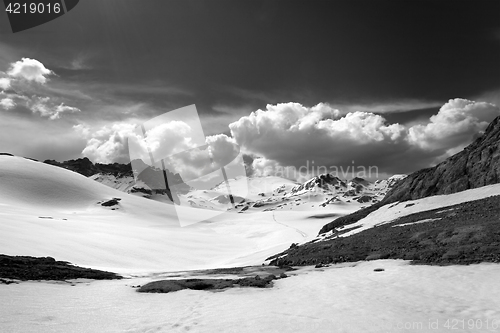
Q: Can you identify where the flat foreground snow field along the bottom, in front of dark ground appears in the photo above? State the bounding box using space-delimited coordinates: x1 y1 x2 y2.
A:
0 260 500 333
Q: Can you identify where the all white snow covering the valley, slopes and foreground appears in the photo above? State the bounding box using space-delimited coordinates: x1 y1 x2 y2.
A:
0 156 500 333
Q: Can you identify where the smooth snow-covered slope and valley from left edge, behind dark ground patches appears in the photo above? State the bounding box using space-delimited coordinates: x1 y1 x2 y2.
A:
0 156 342 273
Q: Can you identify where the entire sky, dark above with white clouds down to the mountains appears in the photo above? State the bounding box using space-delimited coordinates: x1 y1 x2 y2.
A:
0 0 500 180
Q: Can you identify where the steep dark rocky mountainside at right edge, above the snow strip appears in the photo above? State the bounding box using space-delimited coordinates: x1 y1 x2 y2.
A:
383 117 500 204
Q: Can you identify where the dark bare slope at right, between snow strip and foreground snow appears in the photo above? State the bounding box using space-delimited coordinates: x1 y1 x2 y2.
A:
268 196 500 266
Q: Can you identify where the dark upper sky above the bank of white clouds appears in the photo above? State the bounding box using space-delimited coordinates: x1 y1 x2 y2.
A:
1 0 500 112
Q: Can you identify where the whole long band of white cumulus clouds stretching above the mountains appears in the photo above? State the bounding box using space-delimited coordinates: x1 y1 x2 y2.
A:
75 99 500 180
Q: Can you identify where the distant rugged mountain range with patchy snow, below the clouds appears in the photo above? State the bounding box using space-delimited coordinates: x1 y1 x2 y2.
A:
54 158 405 213
